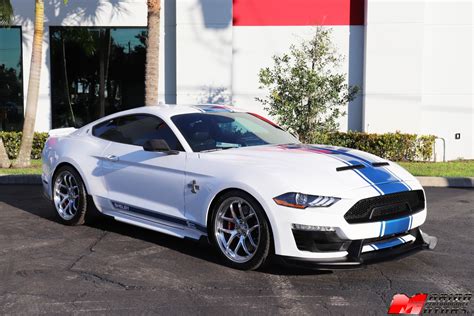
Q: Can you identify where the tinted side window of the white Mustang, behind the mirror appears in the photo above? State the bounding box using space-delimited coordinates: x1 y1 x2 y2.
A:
92 115 183 151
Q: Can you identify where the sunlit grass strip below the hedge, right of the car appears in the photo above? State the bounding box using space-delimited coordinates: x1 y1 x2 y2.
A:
399 160 474 177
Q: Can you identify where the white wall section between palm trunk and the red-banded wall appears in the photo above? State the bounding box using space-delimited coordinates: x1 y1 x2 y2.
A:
176 0 232 104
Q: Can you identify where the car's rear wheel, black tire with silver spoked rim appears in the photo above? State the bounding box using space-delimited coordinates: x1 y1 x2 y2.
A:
52 166 89 226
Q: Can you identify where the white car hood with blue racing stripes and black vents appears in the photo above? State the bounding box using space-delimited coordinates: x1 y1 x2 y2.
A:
202 144 414 194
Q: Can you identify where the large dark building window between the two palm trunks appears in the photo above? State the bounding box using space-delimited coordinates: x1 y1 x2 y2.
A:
50 27 147 128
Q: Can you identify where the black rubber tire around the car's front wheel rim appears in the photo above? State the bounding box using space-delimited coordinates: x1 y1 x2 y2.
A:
208 190 272 270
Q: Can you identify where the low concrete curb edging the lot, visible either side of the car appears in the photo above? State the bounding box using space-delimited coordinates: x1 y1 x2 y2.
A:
0 174 474 188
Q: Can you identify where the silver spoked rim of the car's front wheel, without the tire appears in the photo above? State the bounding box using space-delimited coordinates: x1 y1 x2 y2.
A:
214 197 260 263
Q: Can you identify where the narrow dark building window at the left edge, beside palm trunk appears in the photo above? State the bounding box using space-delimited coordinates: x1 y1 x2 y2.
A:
0 27 23 131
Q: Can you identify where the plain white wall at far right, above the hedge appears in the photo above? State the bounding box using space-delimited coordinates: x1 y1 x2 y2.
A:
364 0 474 160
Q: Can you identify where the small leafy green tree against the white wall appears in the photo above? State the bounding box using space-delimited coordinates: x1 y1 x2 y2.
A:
257 27 359 143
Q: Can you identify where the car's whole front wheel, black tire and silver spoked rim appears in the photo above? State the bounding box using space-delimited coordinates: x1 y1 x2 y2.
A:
210 191 271 270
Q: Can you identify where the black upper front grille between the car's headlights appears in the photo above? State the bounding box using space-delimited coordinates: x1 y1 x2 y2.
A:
344 190 425 224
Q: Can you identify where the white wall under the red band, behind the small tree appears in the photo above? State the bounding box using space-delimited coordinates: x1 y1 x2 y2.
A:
232 26 364 130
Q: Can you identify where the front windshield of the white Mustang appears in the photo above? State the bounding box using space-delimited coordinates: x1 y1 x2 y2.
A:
171 112 299 152
